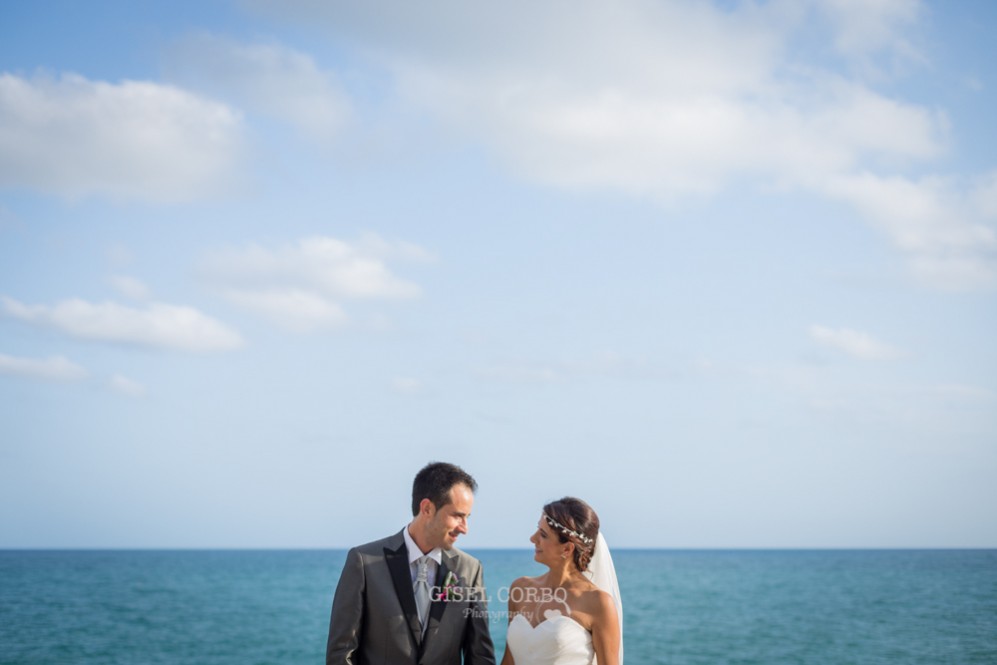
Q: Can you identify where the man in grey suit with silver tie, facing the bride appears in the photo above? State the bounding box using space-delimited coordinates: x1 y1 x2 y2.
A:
325 462 495 665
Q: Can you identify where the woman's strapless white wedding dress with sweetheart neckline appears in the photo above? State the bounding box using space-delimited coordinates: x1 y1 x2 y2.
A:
506 610 595 665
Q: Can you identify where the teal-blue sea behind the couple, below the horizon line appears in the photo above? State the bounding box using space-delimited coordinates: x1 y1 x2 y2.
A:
0 549 997 665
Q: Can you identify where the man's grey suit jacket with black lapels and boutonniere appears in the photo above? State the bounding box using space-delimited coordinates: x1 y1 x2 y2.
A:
325 531 495 665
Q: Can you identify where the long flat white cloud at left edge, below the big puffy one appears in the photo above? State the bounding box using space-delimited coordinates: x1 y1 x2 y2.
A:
0 296 242 352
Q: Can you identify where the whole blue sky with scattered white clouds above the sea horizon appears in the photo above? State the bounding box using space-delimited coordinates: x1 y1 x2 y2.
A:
0 0 997 551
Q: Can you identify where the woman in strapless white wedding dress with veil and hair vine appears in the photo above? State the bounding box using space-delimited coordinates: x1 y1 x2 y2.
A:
502 497 623 665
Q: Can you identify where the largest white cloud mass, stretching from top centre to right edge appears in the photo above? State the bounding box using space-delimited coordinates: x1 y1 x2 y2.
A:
245 0 997 289
